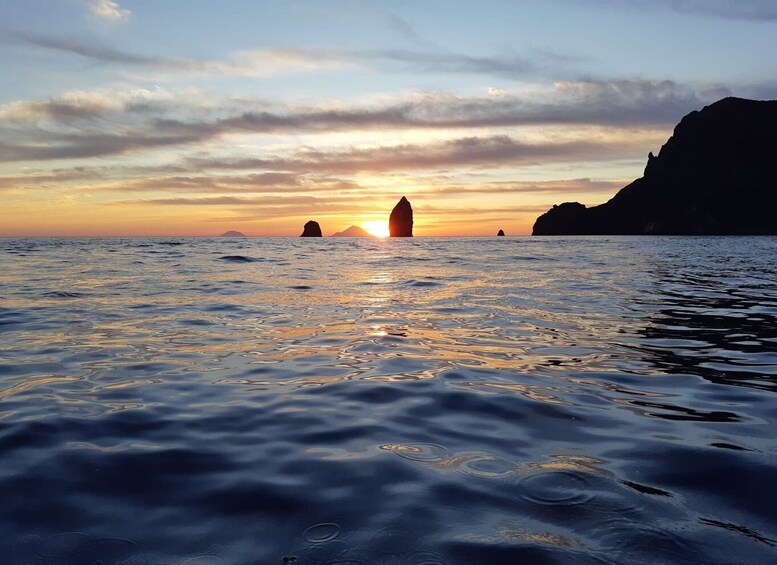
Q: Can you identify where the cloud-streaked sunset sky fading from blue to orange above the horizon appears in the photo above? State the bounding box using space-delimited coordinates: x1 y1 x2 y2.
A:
0 0 777 236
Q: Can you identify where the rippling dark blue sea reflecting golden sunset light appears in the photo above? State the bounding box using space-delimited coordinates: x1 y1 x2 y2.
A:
0 237 777 565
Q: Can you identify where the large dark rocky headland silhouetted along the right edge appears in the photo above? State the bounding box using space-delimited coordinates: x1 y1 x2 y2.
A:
532 98 777 235
